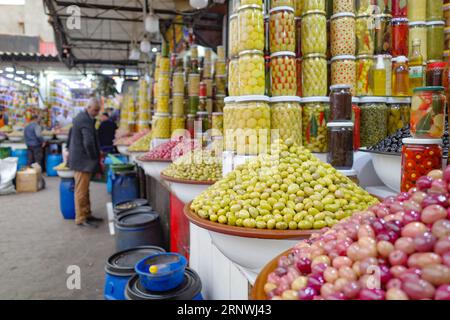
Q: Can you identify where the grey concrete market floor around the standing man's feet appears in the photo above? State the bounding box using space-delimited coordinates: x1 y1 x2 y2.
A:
0 178 115 299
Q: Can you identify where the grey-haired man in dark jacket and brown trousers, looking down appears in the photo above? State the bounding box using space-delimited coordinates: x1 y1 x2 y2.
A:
68 98 102 228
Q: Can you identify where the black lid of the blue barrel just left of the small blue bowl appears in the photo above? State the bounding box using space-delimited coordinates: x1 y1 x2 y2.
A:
105 246 166 276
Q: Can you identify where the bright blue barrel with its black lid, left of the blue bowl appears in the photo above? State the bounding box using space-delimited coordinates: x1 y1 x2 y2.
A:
104 246 165 300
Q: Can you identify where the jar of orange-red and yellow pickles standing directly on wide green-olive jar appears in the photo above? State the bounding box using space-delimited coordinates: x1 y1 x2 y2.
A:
270 51 297 96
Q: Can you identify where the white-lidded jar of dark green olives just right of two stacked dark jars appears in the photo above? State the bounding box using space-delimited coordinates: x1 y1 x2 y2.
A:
360 97 388 147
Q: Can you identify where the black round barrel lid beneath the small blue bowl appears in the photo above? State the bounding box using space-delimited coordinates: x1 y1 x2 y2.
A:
125 268 202 300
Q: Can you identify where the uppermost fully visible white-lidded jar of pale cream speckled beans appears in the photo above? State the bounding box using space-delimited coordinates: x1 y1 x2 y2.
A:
330 12 356 57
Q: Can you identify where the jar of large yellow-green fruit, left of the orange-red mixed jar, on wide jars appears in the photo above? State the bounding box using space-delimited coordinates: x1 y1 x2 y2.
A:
238 50 265 95
